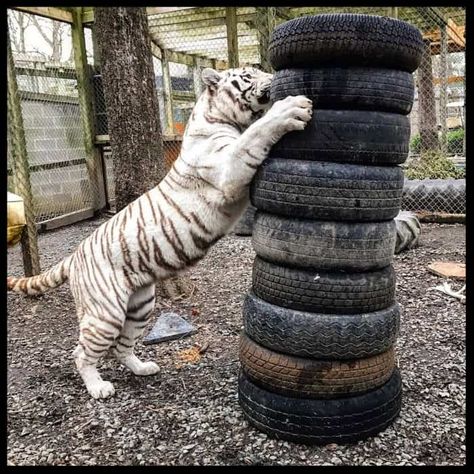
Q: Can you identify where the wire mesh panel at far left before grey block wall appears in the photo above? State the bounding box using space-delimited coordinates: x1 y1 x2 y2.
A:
8 10 100 222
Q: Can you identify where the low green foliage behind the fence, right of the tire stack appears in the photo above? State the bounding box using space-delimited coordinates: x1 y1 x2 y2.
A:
405 151 465 179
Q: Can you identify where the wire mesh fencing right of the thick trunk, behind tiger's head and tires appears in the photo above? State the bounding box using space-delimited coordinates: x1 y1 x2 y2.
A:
149 7 466 213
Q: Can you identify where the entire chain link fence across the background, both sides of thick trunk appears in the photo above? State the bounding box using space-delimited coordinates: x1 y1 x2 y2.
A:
8 7 466 244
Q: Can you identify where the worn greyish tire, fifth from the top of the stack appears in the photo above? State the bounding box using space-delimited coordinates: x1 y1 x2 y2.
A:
252 211 397 272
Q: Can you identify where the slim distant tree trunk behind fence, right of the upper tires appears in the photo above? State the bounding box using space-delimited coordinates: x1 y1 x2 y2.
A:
417 40 439 151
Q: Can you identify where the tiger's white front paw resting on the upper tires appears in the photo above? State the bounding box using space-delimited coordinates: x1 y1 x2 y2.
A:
267 95 313 138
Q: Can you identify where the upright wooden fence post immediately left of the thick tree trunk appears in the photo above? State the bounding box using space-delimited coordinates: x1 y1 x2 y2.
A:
71 7 106 210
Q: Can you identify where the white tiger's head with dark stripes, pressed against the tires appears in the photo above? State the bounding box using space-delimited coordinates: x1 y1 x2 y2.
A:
202 67 273 128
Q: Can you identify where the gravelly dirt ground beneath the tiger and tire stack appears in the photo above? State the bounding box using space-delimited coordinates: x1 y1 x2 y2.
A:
7 218 466 465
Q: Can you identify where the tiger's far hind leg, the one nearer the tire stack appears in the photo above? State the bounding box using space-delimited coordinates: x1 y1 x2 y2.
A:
112 284 160 375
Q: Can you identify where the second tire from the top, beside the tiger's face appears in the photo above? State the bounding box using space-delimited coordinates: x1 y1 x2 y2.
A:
270 67 415 115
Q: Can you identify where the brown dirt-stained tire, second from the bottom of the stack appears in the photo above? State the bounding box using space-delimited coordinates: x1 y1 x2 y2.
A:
239 333 395 398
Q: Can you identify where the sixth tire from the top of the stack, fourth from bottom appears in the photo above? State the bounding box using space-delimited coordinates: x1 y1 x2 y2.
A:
252 257 396 314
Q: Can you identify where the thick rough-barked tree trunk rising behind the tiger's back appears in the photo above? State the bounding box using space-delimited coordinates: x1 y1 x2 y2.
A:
95 7 194 299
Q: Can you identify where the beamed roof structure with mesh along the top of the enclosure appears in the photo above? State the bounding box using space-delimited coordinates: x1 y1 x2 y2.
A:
12 7 466 68
